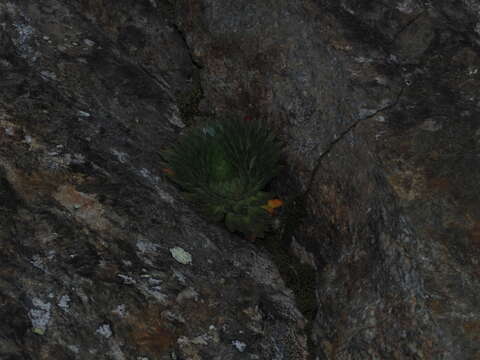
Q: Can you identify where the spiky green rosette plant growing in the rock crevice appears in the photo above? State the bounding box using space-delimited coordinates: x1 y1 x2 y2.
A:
164 118 282 238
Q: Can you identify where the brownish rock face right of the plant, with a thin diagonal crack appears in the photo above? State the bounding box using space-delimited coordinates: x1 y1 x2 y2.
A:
177 0 480 359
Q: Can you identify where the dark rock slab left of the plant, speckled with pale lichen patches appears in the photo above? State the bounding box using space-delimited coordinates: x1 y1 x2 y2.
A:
0 0 307 360
